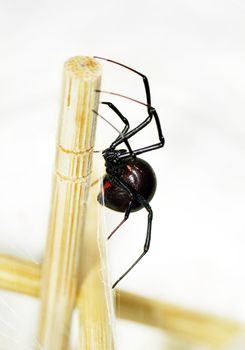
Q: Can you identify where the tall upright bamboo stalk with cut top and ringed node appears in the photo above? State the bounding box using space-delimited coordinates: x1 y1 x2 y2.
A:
39 57 101 350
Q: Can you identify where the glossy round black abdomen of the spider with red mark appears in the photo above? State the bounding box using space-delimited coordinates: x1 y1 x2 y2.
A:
98 157 157 212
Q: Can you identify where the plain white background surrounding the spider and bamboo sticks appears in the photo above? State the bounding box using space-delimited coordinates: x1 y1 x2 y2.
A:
0 0 245 350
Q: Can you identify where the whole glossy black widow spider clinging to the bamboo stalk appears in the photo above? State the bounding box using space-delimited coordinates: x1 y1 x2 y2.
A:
94 56 164 288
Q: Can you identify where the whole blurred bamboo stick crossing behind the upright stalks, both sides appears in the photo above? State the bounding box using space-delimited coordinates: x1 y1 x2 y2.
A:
0 255 244 350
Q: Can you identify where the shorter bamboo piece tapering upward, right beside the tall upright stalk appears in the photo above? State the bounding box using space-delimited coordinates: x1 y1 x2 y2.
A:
77 176 115 350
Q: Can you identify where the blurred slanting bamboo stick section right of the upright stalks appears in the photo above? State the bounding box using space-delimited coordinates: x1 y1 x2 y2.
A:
116 291 242 349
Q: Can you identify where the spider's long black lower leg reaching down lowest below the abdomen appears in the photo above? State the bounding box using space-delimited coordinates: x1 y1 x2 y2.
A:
112 194 153 288
